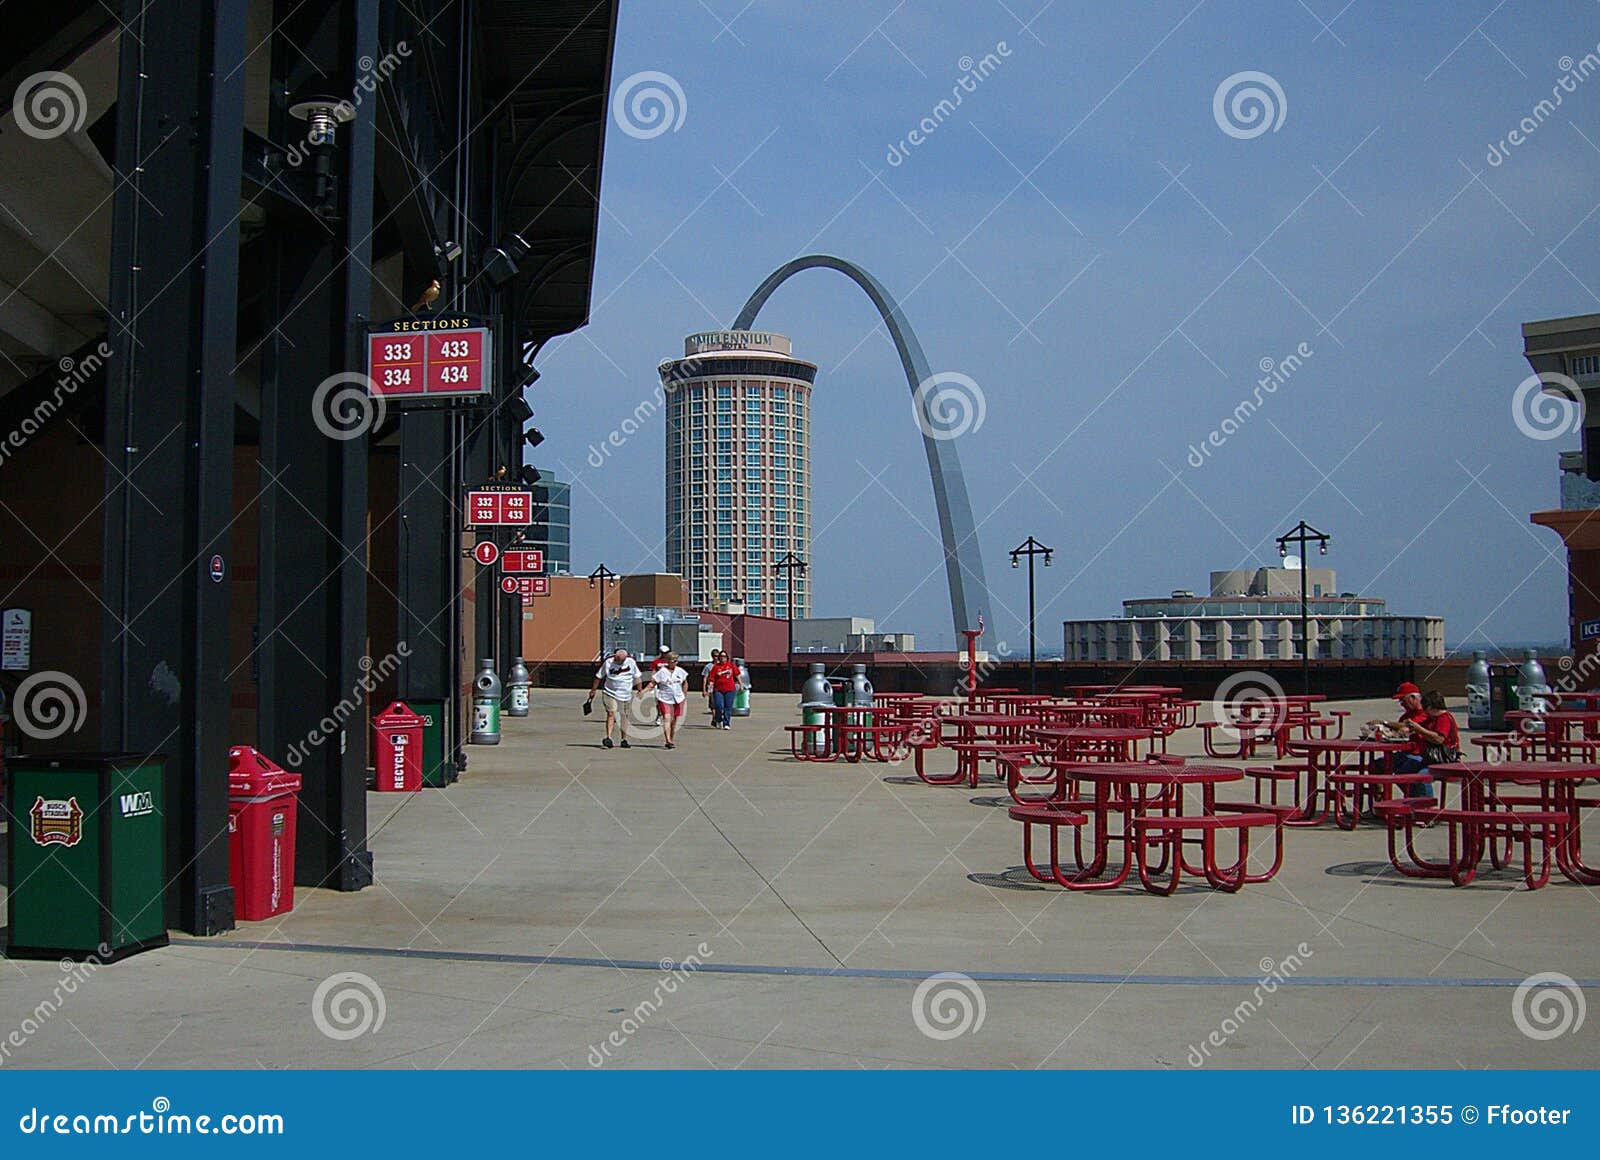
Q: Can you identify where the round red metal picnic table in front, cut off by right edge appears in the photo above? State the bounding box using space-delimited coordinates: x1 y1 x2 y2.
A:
1384 762 1600 890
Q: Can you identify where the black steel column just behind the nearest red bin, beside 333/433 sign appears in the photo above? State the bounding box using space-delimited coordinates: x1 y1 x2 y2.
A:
261 0 379 890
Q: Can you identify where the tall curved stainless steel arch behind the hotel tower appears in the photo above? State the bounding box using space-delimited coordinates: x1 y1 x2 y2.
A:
733 254 989 645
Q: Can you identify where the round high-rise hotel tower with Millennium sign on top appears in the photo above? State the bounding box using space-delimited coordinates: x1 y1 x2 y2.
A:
659 330 816 618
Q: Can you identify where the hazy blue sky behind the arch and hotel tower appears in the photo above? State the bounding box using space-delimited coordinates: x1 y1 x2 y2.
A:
530 0 1600 648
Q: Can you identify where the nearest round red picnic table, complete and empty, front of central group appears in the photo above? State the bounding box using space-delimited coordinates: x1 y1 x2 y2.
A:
1010 762 1283 894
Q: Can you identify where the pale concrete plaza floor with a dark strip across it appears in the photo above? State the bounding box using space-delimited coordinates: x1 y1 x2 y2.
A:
0 690 1600 1069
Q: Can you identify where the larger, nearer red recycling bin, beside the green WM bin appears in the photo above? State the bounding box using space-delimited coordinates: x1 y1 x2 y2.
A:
227 746 301 922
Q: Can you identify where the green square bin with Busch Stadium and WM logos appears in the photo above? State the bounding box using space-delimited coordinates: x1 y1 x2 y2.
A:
6 754 166 963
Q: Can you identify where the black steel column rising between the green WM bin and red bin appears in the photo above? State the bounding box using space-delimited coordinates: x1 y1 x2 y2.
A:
102 0 246 934
